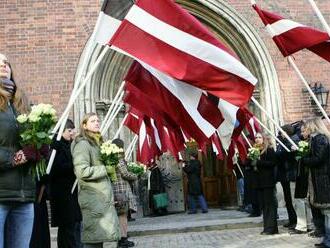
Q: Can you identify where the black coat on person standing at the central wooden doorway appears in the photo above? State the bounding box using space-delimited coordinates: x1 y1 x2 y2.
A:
183 159 203 195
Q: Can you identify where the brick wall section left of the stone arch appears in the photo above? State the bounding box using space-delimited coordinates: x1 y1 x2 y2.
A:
0 0 100 112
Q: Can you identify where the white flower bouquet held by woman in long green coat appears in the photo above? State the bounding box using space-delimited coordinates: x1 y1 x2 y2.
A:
100 140 124 182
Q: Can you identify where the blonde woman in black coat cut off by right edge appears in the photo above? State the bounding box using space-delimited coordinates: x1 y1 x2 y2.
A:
301 118 330 247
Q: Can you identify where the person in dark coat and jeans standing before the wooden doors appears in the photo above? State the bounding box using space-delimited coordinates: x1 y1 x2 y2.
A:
183 152 208 214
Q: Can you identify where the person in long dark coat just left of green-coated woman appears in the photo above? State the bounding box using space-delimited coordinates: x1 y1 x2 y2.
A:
50 120 82 248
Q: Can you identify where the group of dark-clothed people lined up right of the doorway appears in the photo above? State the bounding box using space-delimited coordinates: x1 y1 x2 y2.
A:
235 118 330 247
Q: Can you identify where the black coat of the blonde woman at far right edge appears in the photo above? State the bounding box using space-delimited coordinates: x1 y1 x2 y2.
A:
302 134 330 208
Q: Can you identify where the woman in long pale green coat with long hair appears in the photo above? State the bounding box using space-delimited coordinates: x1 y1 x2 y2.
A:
71 113 120 248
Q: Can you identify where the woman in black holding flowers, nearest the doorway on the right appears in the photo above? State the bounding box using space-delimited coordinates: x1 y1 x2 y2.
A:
248 133 278 235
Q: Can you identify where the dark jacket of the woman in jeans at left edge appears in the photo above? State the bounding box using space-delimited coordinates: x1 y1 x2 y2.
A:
0 104 35 202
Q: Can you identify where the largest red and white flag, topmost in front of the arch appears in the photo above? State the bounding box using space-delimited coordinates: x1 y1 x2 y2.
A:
109 0 257 106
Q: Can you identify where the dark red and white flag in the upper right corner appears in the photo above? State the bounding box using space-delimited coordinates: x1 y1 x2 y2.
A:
253 5 330 62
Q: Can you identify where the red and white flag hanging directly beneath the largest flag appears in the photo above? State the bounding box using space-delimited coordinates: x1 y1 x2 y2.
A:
125 62 223 145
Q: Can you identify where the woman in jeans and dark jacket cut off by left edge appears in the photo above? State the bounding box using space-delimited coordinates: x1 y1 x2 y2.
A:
0 53 35 248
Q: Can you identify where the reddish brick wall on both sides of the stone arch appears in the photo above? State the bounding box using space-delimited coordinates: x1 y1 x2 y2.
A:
0 0 330 122
